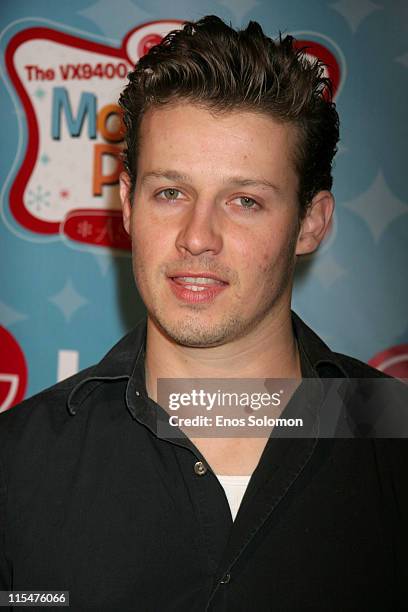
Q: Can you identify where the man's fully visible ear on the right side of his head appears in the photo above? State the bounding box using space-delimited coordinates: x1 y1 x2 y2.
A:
296 191 334 255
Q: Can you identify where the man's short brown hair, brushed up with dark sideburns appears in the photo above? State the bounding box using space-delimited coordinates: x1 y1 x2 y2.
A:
119 15 339 218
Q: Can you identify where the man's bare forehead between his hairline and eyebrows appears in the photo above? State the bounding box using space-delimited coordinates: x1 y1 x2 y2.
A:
137 102 298 195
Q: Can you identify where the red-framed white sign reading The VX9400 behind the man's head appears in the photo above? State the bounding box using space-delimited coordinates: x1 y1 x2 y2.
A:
6 20 341 250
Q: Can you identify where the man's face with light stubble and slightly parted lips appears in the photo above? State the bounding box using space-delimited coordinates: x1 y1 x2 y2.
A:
121 103 304 347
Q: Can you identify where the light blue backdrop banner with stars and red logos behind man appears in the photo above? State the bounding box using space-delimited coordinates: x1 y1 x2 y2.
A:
0 0 408 411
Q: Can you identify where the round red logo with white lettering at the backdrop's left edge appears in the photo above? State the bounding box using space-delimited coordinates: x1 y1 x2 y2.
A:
0 325 27 412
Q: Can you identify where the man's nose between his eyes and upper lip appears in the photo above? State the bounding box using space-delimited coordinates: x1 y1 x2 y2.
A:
176 200 222 255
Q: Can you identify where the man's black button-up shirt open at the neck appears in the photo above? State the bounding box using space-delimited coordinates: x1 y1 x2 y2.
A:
0 313 408 612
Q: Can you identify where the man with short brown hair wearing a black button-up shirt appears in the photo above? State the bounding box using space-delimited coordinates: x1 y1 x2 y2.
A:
0 16 407 612
